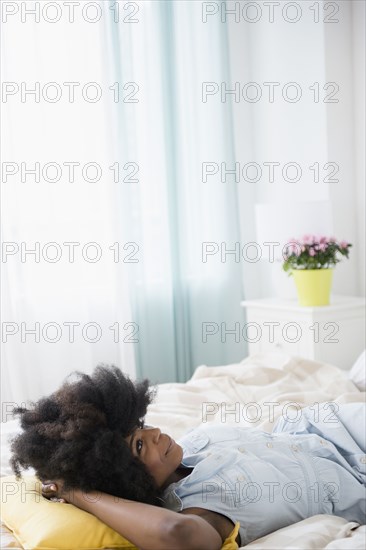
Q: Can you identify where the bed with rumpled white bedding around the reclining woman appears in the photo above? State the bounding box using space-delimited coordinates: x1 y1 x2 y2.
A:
1 353 366 550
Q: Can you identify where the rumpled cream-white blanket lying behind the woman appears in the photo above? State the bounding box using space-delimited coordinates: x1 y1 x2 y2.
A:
146 353 366 438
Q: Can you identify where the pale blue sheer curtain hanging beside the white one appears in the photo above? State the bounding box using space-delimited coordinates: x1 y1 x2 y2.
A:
106 2 245 381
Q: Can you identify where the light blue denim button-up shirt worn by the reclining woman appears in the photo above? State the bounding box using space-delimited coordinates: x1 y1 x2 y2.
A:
164 403 366 545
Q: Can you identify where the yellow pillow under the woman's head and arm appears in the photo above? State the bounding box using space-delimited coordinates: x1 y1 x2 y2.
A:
1 476 136 550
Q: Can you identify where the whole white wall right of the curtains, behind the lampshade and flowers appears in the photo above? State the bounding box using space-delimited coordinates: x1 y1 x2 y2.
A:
228 1 365 298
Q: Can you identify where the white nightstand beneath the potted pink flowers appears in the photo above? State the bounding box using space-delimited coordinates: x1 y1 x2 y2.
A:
241 296 366 369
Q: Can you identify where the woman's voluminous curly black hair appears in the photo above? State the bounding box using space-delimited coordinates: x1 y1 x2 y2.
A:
11 365 161 506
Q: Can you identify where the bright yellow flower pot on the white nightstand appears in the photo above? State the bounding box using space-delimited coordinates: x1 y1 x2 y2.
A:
292 269 333 306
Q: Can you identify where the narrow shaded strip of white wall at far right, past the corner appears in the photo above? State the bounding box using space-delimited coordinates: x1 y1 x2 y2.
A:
325 1 365 294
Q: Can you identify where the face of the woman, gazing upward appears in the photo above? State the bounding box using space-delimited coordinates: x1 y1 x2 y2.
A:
126 426 183 487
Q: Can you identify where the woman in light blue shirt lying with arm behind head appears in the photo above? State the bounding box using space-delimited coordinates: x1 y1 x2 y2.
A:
12 366 366 550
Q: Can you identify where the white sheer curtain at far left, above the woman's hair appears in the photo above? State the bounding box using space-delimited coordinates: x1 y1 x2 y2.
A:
1 9 135 414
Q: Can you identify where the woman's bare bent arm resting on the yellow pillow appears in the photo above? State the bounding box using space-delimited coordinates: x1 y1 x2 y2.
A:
44 489 222 550
